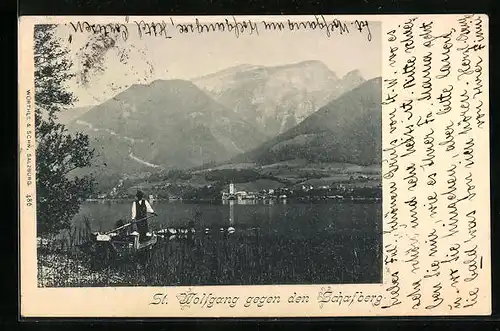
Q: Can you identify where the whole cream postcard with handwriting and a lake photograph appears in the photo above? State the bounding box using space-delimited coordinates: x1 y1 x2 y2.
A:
18 14 491 317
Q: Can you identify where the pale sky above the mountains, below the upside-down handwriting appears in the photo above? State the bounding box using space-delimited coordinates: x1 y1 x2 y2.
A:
57 18 381 106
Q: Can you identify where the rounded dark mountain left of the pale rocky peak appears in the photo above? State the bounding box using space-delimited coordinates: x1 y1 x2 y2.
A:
73 80 267 168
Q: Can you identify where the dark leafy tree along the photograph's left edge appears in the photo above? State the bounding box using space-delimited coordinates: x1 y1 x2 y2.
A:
34 25 95 236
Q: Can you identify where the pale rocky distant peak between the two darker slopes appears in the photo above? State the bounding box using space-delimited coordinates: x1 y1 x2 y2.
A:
193 61 364 137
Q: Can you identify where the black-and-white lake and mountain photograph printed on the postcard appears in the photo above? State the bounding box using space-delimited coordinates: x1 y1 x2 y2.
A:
32 18 383 288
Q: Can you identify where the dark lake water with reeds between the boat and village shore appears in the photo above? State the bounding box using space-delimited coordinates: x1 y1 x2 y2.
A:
74 201 382 286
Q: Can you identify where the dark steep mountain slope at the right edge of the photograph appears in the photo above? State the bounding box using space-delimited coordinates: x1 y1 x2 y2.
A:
234 78 382 165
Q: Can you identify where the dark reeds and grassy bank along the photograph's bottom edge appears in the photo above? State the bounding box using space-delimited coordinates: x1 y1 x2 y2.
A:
38 228 381 287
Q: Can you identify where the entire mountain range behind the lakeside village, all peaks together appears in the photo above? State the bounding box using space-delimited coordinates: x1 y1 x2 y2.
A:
61 61 381 188
